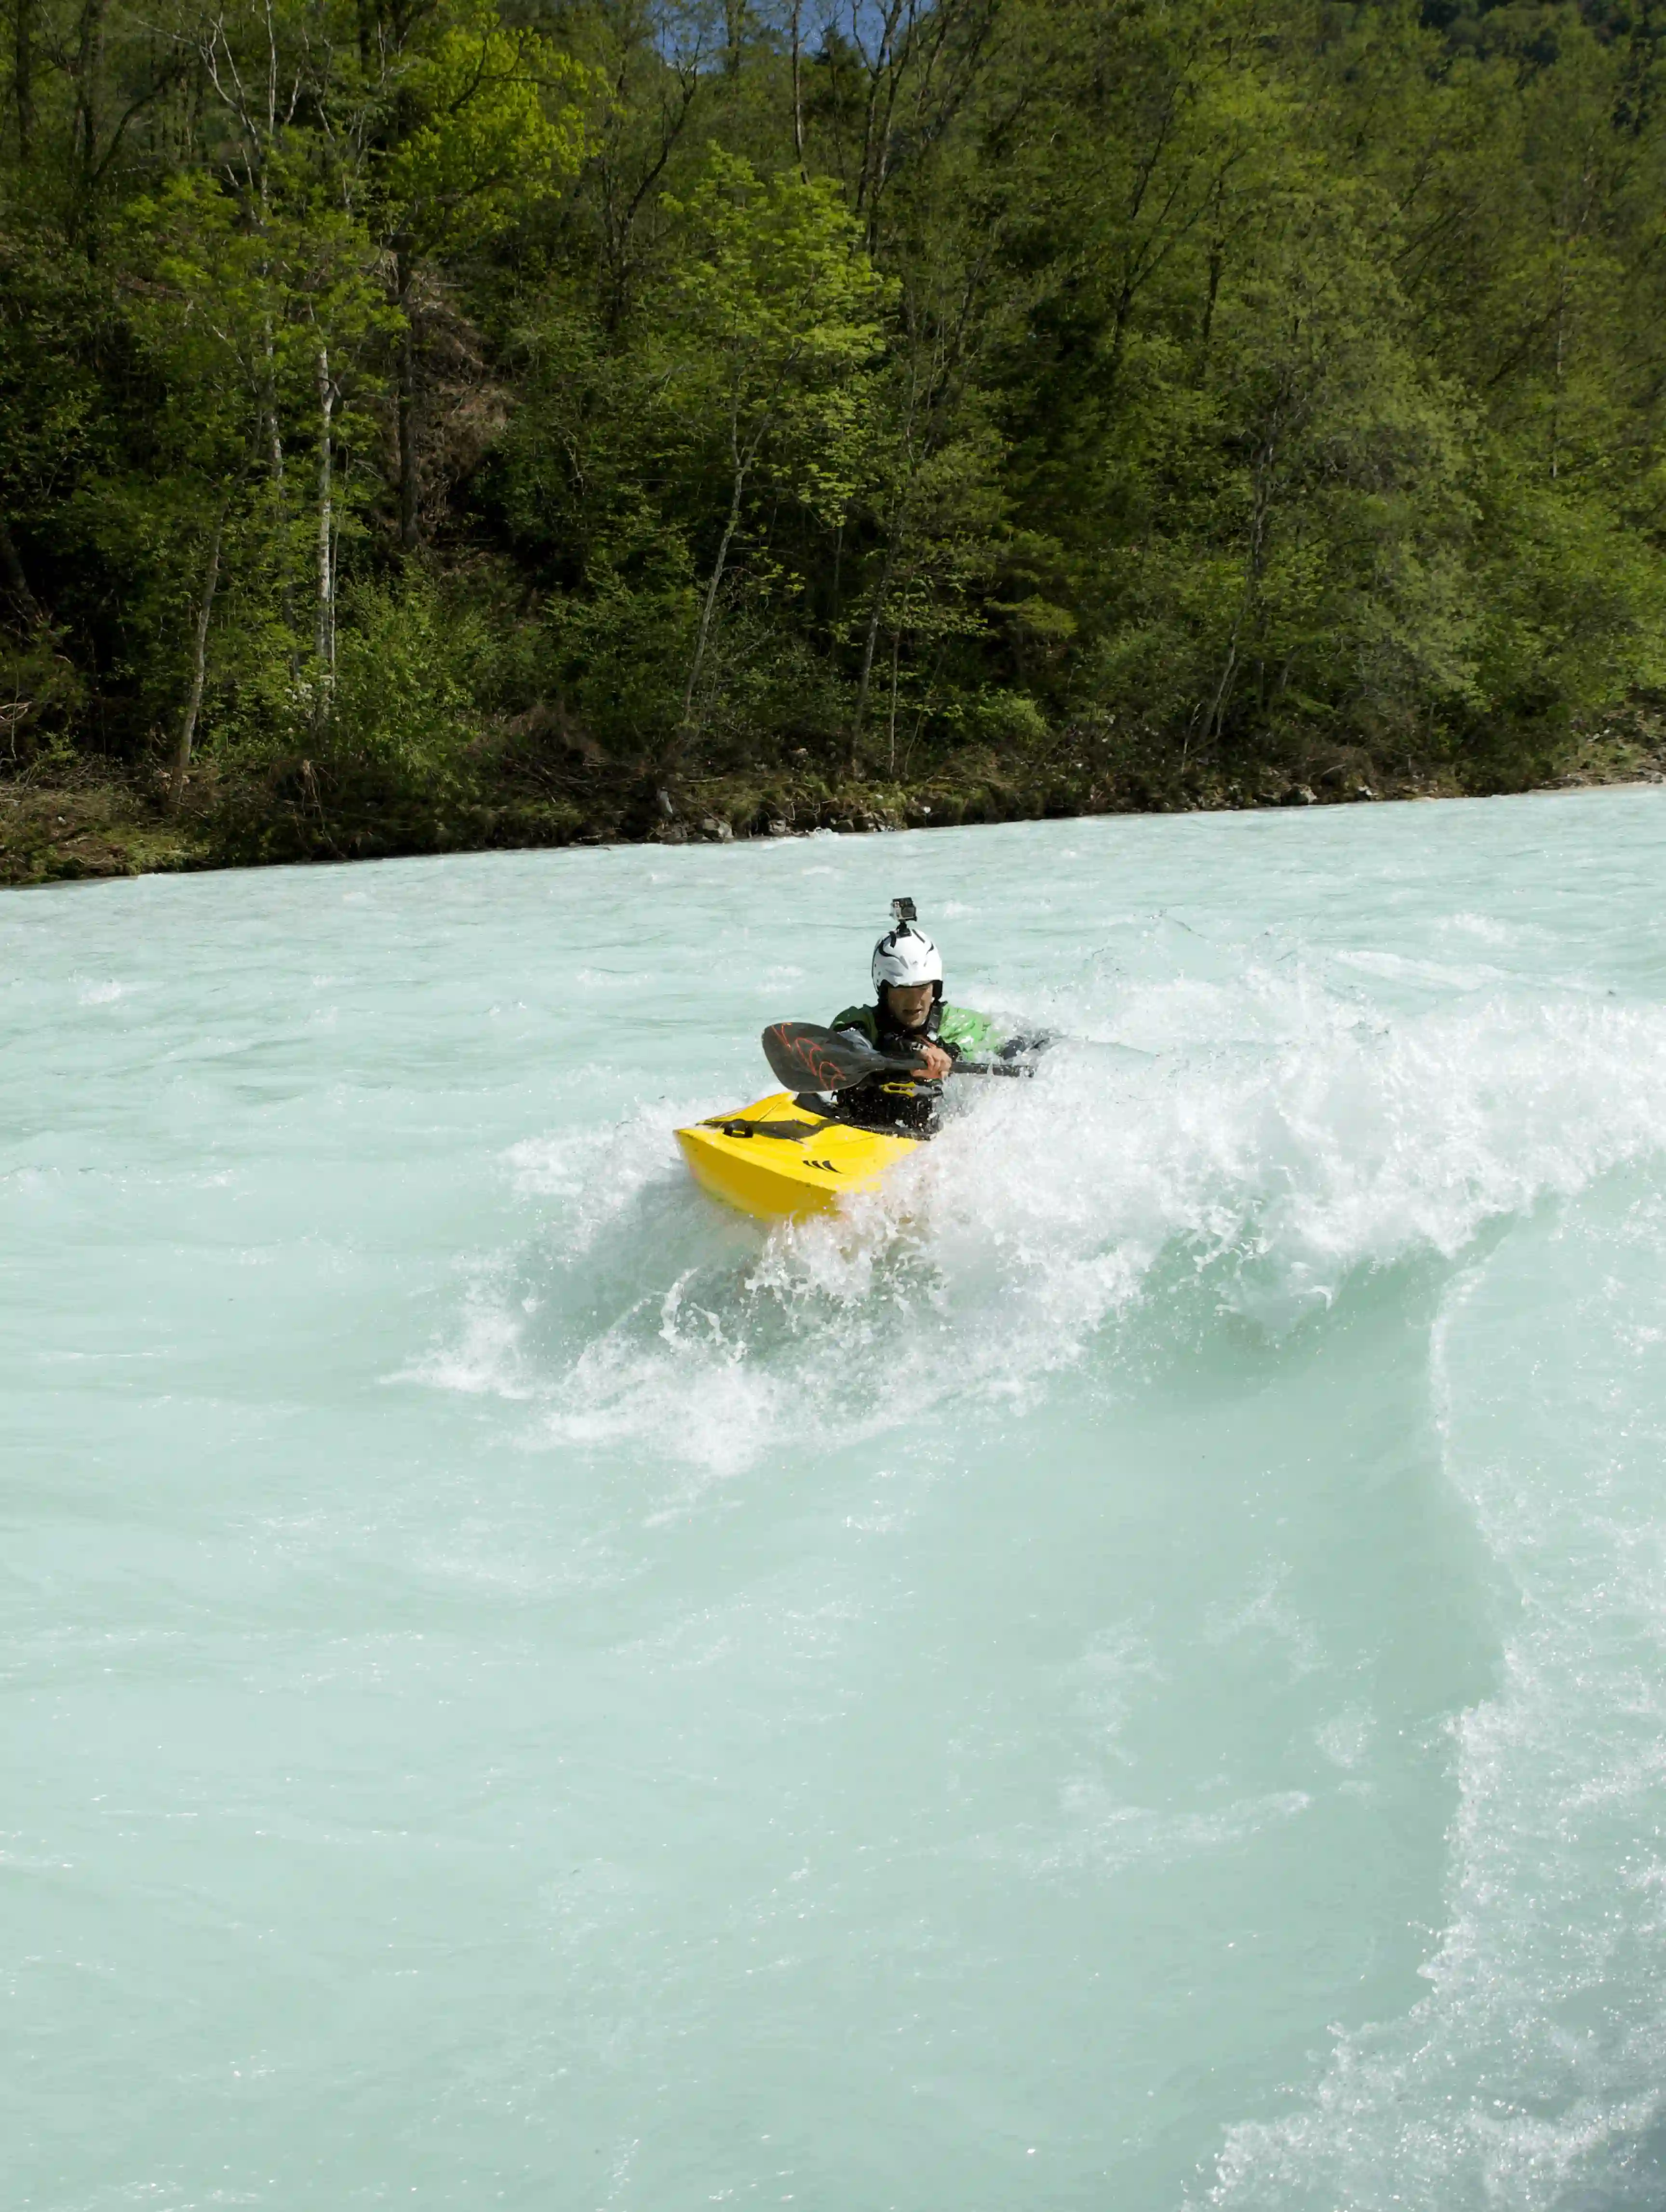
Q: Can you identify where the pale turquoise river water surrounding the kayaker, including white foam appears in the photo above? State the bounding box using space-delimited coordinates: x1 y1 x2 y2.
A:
0 790 1666 2212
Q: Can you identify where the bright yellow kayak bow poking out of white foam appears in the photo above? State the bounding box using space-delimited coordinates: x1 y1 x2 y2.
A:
677 1091 918 1221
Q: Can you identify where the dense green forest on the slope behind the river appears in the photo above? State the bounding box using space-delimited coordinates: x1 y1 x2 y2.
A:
0 0 1666 880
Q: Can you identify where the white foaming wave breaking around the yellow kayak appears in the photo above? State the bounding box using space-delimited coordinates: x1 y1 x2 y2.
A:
423 958 1666 1475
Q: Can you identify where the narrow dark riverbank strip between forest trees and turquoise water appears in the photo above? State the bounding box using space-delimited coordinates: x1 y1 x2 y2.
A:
0 715 1666 887
